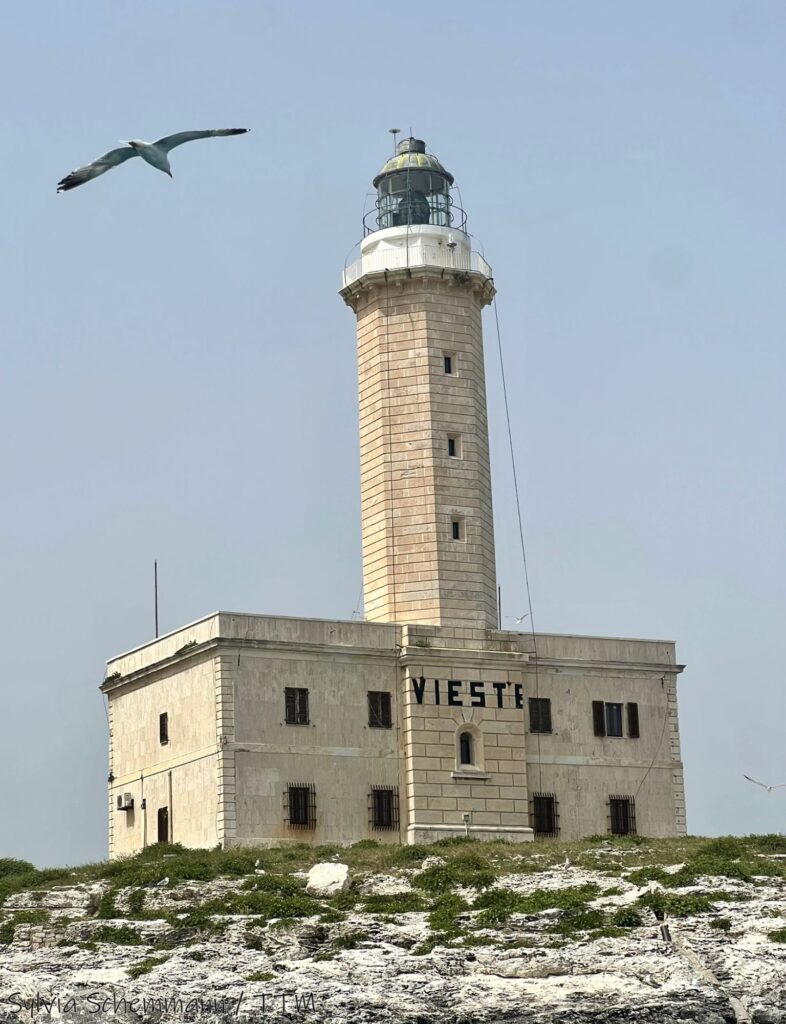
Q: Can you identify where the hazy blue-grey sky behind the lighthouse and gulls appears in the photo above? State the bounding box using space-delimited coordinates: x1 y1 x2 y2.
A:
0 0 786 864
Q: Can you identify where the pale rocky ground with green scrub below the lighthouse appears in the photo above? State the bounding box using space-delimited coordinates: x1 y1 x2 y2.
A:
0 841 786 1024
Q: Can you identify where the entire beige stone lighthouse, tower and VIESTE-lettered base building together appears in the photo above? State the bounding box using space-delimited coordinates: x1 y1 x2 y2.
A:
101 138 686 856
